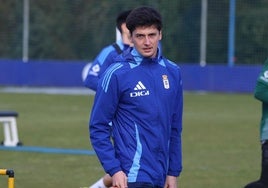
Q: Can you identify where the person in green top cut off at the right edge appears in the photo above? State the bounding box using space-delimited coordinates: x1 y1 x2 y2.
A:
245 59 268 188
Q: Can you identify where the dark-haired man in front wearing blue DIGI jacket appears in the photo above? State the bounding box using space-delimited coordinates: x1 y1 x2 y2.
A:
89 7 183 188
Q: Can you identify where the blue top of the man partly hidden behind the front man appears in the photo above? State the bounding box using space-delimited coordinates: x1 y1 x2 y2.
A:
84 41 129 91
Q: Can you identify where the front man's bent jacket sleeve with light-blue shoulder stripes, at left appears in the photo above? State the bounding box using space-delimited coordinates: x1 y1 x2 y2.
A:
89 64 121 176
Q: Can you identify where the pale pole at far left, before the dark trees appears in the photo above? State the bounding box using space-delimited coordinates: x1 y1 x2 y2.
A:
22 0 30 63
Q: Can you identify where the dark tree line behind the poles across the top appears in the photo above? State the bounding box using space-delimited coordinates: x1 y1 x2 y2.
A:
0 0 268 64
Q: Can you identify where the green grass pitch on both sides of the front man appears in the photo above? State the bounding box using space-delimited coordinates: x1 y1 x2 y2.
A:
0 92 261 188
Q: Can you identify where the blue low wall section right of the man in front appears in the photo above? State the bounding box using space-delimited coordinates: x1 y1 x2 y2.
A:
181 65 261 92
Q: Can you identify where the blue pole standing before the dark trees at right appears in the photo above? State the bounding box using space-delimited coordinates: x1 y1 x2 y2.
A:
228 0 236 67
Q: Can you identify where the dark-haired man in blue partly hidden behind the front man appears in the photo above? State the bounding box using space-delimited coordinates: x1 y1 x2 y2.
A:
84 10 132 91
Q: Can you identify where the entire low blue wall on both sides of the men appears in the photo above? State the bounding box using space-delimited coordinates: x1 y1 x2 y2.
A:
0 60 261 93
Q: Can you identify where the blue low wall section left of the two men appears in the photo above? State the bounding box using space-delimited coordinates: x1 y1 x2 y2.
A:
0 60 85 87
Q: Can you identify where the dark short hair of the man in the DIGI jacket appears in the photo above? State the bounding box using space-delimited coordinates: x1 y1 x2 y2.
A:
126 6 162 34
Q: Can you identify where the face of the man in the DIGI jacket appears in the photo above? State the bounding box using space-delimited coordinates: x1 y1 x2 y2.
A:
131 26 162 58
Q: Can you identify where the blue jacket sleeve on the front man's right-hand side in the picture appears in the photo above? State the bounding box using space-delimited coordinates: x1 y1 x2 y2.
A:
168 67 183 176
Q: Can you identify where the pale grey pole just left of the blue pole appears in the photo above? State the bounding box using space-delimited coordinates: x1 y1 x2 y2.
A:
200 0 208 67
